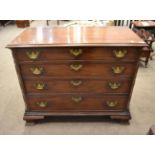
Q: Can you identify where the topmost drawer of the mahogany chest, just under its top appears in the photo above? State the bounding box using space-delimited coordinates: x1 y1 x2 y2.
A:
16 47 140 61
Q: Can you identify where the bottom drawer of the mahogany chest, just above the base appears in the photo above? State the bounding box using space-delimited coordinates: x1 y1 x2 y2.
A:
28 94 128 112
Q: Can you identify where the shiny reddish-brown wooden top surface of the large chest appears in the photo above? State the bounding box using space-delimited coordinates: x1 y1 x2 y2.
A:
7 26 145 48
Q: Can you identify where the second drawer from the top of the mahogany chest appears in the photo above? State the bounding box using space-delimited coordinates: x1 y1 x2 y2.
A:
20 62 137 77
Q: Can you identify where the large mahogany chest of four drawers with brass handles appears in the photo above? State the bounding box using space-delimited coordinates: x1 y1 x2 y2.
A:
7 27 146 122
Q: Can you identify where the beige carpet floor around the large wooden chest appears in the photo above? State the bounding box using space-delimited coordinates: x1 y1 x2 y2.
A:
0 21 155 135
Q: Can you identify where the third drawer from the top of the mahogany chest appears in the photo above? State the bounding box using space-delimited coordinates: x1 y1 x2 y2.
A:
24 78 131 93
